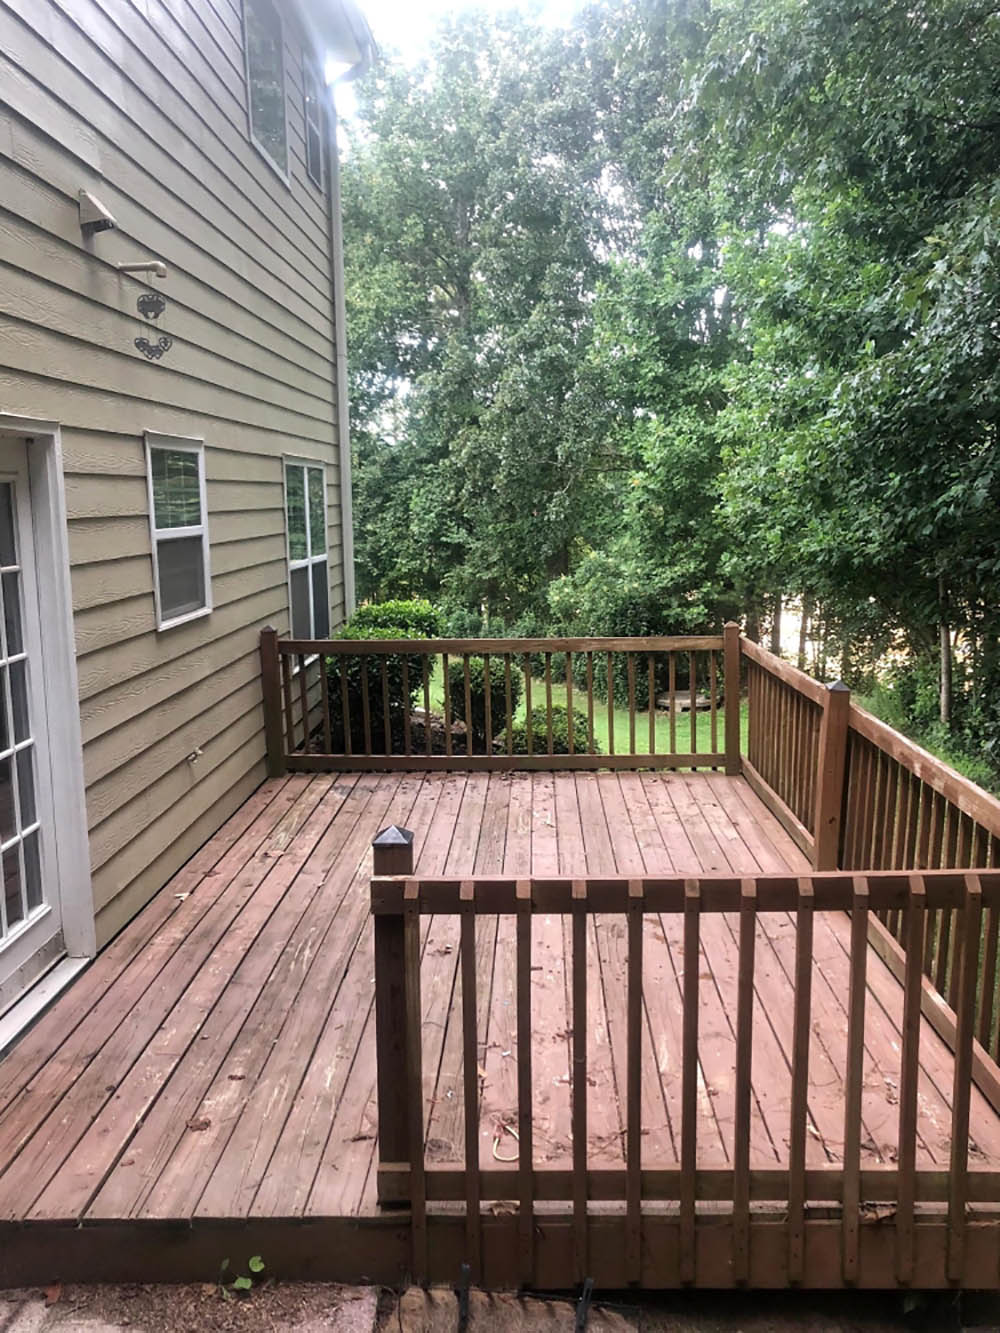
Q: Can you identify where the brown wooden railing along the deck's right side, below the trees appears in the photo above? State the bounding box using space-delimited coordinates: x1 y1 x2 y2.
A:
740 639 1000 1112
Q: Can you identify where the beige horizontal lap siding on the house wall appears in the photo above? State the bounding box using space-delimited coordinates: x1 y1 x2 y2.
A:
0 0 344 942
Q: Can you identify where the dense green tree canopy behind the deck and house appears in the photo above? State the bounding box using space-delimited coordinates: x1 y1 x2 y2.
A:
344 0 1000 761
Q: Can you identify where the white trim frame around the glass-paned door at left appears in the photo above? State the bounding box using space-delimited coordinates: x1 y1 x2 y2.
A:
0 412 97 958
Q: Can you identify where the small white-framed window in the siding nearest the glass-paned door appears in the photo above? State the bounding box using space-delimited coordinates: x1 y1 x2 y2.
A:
145 435 212 629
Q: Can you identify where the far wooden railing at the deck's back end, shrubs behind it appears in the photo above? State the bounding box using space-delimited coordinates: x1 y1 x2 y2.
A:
260 625 740 776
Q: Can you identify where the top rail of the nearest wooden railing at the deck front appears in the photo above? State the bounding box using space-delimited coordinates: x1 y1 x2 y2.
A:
371 870 1000 916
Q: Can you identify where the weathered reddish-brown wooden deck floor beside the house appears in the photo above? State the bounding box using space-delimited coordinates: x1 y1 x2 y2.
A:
0 772 1000 1285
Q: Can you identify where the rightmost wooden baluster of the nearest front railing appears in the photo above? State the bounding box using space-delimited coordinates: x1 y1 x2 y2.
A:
947 873 983 1282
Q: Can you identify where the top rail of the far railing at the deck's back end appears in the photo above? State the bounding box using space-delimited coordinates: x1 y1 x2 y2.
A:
277 635 725 657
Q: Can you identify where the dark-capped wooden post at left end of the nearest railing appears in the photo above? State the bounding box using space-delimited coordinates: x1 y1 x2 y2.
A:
372 824 420 1204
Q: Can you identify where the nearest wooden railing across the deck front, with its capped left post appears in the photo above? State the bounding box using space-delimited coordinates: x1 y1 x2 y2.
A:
371 829 1000 1285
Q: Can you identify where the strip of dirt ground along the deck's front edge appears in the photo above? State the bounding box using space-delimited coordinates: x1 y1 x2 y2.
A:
0 1280 1000 1333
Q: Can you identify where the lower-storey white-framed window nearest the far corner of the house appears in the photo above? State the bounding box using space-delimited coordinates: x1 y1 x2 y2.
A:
285 463 329 639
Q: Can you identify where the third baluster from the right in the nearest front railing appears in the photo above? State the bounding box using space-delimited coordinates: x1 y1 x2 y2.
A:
843 874 871 1285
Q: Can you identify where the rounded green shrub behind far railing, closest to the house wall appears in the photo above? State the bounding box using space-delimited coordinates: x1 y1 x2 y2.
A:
325 600 440 754
